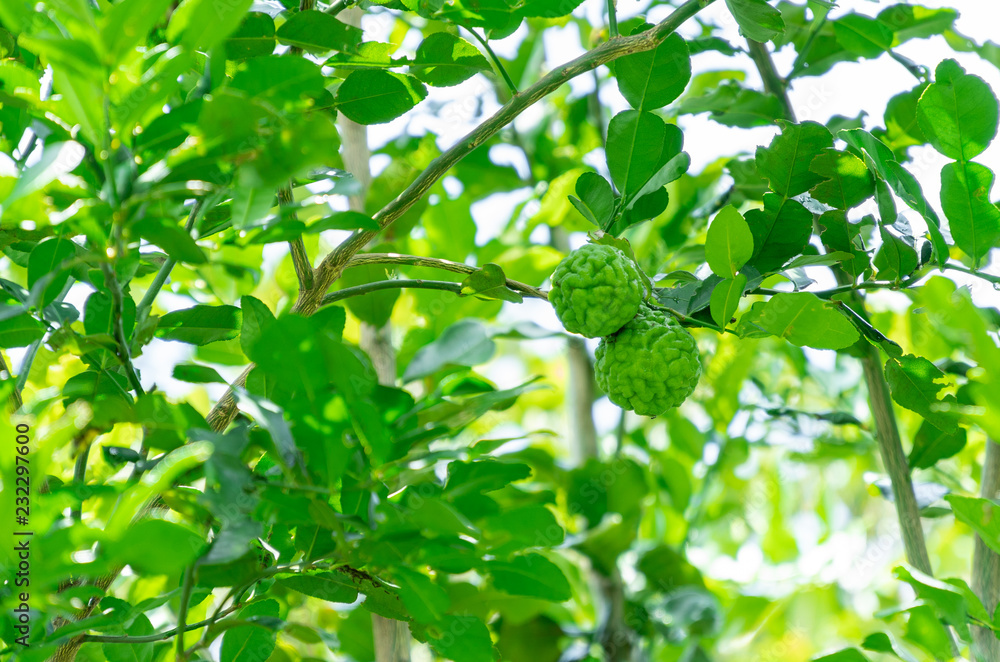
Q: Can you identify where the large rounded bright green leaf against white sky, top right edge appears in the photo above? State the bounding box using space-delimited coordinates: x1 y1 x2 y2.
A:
917 60 998 161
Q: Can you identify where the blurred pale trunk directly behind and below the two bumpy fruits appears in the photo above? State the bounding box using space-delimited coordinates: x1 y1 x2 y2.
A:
552 228 634 662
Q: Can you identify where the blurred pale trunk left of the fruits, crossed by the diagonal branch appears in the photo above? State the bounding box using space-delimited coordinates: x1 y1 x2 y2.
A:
337 9 410 662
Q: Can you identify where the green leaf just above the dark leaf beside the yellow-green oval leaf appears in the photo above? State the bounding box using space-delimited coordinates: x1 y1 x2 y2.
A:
757 121 833 198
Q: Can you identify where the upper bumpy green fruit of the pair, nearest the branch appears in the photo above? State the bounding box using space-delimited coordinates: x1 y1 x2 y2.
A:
549 244 645 338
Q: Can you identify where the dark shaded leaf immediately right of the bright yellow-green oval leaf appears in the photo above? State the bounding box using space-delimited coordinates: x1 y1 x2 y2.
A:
746 192 813 273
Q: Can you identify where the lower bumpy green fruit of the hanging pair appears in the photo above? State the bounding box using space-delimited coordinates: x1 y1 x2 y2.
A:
594 306 701 416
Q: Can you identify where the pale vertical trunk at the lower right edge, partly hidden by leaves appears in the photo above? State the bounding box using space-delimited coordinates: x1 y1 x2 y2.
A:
972 439 1000 660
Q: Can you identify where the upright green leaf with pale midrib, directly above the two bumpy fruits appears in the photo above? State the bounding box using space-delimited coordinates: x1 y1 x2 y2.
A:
606 110 680 196
